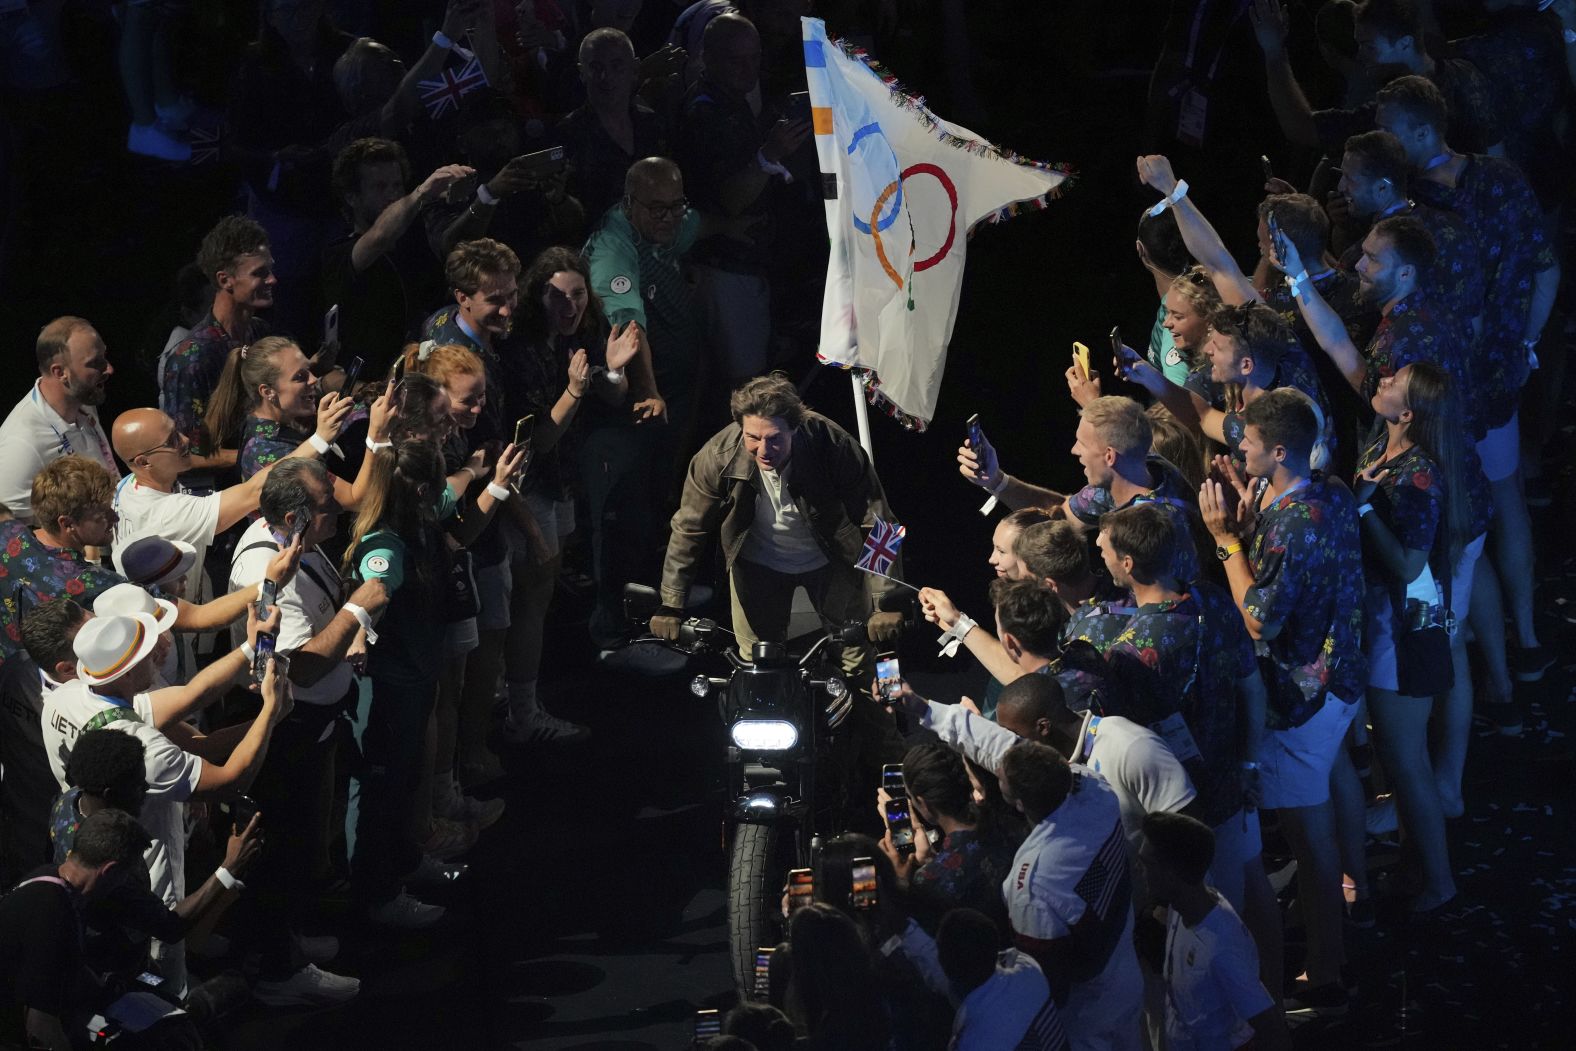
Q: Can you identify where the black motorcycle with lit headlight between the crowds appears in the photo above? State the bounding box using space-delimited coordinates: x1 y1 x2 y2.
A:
624 585 865 999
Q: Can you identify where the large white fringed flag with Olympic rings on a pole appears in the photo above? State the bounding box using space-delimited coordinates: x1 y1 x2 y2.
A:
802 19 1070 430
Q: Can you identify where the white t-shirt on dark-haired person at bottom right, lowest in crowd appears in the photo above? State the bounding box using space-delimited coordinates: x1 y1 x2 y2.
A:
1163 892 1273 1051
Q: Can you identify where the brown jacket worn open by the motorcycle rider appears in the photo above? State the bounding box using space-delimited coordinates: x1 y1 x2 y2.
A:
662 411 901 610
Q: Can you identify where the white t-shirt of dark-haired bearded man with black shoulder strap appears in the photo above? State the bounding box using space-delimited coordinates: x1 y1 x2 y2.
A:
229 518 353 705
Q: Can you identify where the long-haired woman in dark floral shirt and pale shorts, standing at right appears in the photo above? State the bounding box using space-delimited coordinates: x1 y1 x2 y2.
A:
1354 361 1483 912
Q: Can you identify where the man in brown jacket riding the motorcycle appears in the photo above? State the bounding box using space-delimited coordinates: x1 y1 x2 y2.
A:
651 373 903 734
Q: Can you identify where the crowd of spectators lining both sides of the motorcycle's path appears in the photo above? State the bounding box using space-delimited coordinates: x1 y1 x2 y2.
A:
0 0 1576 1051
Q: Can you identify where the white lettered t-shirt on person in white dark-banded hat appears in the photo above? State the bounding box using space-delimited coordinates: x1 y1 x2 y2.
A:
43 679 202 908
